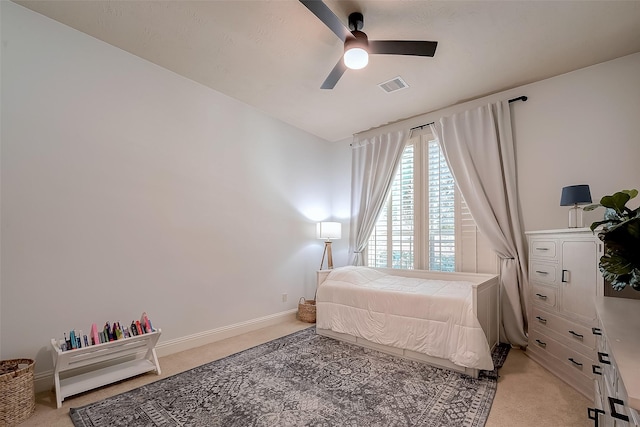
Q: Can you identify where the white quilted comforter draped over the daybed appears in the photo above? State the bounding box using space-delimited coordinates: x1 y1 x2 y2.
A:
316 266 493 370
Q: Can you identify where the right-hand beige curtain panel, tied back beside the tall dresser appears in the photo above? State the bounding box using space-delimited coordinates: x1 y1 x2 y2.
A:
431 101 528 346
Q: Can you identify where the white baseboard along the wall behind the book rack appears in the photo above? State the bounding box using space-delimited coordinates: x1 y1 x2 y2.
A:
33 308 298 393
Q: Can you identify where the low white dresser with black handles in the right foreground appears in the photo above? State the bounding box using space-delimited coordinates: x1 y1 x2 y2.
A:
588 297 640 427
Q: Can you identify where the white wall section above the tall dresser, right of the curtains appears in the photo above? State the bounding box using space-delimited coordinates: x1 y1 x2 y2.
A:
513 54 640 234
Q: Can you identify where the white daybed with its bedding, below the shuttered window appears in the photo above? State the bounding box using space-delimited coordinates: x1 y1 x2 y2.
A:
316 266 499 378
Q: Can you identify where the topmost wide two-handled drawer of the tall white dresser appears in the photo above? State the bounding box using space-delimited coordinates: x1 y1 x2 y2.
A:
531 307 596 359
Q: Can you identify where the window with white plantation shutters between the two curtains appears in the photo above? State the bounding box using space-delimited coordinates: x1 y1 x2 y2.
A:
367 134 497 272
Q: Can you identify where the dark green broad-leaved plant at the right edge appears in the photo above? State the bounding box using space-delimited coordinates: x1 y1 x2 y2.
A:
584 190 640 291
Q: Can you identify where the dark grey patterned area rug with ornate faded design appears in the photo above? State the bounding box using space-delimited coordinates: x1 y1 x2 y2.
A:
69 327 509 427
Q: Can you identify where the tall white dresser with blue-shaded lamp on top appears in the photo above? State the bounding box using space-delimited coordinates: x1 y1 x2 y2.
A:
526 228 604 399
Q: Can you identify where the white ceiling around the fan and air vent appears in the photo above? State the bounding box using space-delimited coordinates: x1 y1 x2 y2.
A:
16 0 640 141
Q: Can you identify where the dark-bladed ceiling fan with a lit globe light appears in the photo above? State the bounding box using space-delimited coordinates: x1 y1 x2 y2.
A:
300 0 438 89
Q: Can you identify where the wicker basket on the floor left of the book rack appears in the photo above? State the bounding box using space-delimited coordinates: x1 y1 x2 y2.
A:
0 359 36 427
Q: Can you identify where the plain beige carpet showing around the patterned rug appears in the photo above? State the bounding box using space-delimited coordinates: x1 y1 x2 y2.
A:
21 320 592 427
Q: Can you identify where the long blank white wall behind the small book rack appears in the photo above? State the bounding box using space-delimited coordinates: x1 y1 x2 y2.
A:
0 2 332 380
